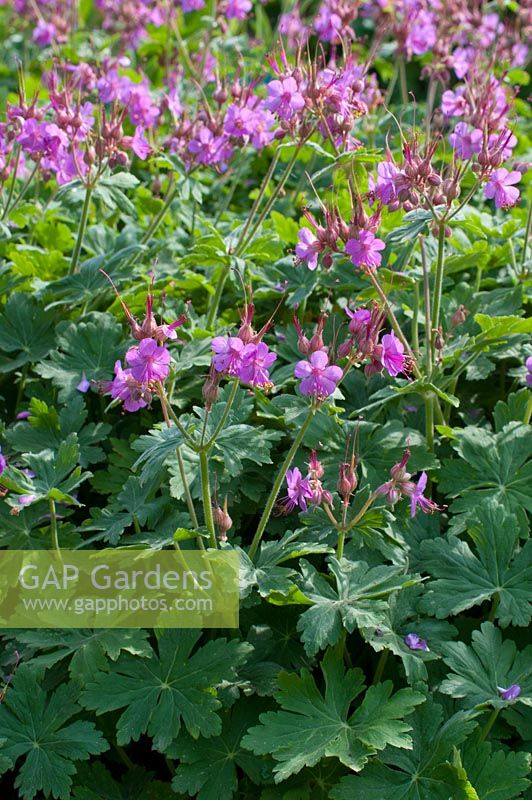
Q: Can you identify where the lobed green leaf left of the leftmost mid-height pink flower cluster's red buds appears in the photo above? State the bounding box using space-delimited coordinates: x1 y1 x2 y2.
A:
35 312 124 402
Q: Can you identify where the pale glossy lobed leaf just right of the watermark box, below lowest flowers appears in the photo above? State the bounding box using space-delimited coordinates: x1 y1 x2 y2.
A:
297 557 418 655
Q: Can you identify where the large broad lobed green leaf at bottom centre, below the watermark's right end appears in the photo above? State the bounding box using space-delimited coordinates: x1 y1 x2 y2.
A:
242 649 425 783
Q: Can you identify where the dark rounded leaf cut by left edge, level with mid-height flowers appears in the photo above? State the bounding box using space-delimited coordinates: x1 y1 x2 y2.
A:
0 292 55 372
